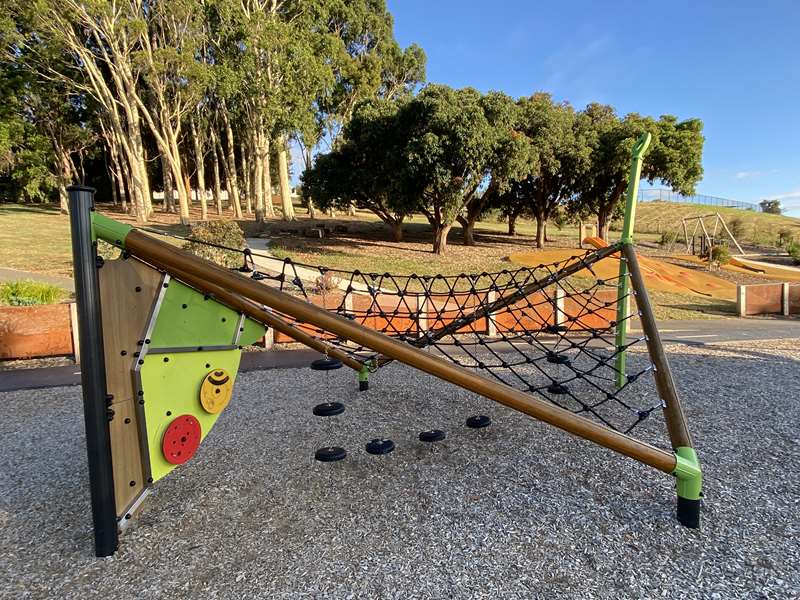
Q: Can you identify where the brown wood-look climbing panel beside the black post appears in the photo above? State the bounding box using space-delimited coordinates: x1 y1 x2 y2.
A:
100 259 161 517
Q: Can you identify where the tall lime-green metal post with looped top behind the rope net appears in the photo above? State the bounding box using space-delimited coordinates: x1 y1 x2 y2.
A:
616 133 652 388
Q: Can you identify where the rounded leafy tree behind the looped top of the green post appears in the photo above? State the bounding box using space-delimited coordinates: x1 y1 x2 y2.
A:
571 104 704 239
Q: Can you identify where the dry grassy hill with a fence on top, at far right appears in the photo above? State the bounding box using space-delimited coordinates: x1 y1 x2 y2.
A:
636 202 800 246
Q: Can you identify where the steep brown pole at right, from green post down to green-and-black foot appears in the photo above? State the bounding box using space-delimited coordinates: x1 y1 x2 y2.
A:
622 244 692 448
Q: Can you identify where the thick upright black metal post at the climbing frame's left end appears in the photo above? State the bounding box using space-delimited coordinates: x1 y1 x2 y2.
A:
67 186 118 556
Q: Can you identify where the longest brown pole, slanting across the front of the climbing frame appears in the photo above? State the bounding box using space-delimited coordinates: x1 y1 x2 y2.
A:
125 230 677 473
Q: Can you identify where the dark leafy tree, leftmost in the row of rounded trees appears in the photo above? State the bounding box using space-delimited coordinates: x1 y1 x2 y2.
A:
302 100 414 242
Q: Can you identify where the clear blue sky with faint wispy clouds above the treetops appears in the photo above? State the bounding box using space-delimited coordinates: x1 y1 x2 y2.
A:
387 0 800 216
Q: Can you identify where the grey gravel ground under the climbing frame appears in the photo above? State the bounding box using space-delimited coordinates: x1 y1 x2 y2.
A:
0 341 800 599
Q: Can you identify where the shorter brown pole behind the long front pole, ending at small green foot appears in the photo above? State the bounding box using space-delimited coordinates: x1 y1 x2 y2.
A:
163 269 365 372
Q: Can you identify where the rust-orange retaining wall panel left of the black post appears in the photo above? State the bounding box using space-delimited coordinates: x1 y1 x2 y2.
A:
0 304 72 358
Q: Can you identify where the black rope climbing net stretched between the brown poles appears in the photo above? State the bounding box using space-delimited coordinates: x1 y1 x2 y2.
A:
142 227 662 433
